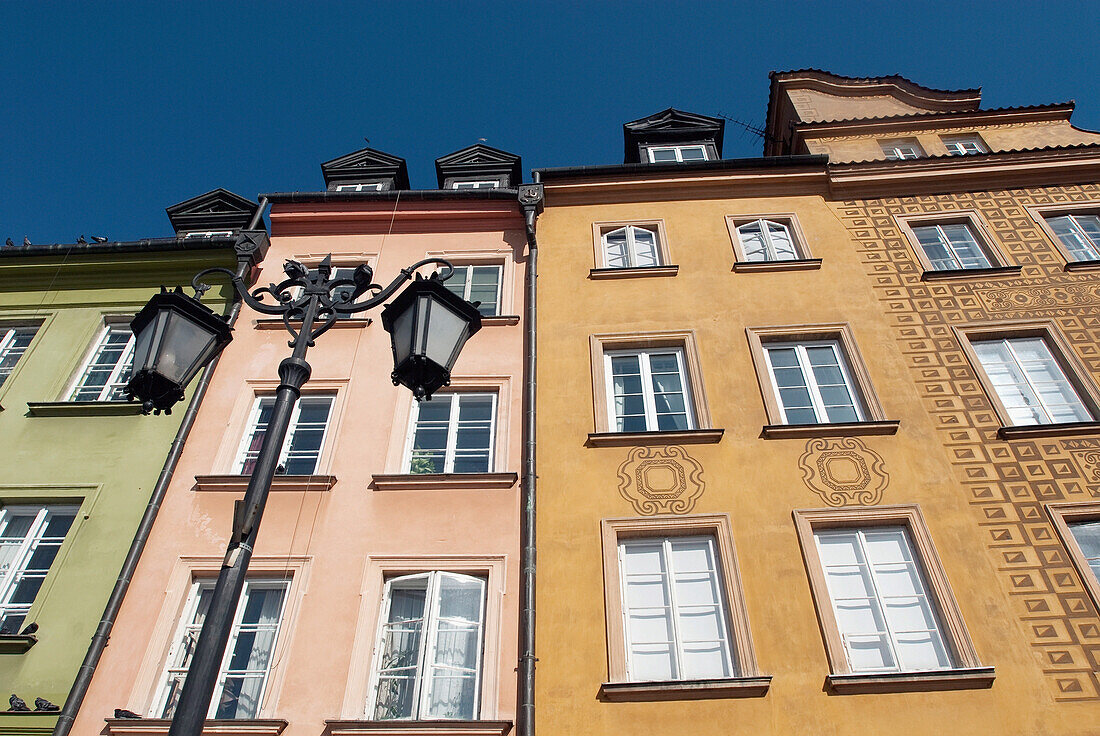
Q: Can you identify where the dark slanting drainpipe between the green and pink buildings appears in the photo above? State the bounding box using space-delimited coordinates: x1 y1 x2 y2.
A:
53 197 268 736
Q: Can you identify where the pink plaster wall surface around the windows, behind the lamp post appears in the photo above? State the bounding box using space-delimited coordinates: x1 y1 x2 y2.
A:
75 199 525 736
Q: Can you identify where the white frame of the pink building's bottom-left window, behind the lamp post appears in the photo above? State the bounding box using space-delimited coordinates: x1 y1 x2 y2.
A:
156 576 292 718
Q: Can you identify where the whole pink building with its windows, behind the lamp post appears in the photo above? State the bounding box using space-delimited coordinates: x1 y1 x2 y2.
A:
74 146 527 736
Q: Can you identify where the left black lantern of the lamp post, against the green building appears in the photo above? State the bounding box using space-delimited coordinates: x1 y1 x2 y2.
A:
127 286 232 414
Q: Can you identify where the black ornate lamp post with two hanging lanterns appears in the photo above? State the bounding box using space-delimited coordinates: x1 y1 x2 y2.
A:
127 249 481 736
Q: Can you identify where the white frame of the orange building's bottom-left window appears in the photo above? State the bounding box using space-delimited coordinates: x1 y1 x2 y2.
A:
617 535 738 682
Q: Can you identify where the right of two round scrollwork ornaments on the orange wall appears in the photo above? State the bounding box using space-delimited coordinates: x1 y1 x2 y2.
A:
799 437 890 506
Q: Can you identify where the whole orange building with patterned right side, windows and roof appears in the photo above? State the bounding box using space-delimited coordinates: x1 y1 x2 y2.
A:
536 70 1100 735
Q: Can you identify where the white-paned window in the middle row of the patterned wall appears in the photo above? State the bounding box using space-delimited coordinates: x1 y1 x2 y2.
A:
970 336 1093 425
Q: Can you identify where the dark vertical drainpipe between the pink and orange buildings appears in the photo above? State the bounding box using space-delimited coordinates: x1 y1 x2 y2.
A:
516 182 542 736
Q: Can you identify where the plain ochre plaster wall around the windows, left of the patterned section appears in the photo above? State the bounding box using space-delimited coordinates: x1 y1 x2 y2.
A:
536 183 1098 736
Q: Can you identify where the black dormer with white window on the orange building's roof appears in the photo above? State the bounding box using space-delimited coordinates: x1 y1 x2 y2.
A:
623 108 726 164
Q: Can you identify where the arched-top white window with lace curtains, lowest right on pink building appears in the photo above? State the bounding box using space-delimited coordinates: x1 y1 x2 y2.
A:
367 572 485 721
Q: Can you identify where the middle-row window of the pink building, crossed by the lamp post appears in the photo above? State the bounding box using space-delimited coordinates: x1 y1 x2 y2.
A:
233 396 332 475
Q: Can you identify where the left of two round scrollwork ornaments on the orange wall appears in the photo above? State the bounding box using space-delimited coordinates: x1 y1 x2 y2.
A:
618 446 705 516
